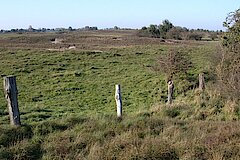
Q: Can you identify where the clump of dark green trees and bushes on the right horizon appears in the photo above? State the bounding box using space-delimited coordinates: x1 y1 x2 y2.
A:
138 19 222 40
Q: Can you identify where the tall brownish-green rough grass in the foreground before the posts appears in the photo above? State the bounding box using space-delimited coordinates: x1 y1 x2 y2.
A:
0 113 240 160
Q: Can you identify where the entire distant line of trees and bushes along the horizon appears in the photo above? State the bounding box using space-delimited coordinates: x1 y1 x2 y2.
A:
0 22 222 40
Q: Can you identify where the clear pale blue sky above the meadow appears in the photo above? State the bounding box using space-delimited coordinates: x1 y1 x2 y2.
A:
0 0 240 30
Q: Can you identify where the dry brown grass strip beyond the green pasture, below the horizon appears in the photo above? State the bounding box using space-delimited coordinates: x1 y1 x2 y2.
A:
0 30 199 51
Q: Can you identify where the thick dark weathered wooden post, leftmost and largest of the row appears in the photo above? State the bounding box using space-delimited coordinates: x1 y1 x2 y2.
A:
3 76 21 126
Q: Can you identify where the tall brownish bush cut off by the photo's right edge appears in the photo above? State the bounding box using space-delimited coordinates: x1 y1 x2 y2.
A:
217 9 240 100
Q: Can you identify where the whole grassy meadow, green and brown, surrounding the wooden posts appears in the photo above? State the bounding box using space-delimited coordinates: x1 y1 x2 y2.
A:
0 31 240 160
